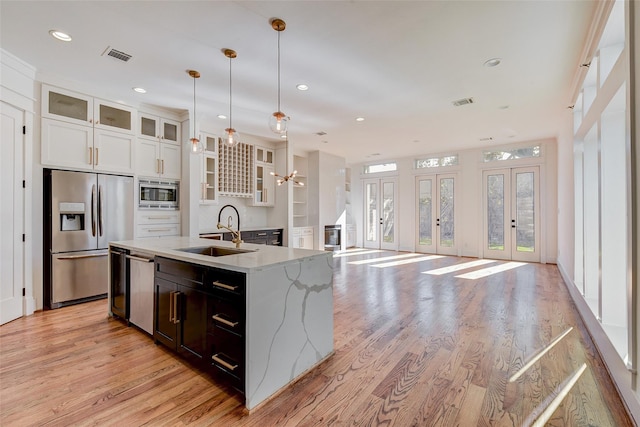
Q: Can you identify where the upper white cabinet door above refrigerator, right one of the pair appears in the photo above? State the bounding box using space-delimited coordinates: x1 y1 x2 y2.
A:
93 129 136 173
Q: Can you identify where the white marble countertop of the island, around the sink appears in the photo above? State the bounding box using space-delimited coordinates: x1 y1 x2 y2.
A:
109 237 333 273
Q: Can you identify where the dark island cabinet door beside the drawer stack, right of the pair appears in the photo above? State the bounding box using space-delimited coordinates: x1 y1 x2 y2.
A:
178 286 207 360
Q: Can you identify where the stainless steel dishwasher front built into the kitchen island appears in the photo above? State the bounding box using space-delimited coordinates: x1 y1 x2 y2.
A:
127 252 154 335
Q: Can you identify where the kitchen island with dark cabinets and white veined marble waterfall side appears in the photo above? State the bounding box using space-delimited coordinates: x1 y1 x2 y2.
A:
109 237 333 409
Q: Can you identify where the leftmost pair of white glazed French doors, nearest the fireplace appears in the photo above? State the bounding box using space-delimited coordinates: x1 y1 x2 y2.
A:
363 178 398 251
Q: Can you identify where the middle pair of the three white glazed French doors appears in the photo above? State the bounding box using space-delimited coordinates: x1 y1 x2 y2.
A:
415 174 457 255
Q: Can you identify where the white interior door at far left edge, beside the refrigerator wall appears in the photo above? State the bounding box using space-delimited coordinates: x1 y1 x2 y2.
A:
0 102 24 324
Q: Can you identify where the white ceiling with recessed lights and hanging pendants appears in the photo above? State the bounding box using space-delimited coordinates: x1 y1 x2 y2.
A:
0 0 597 163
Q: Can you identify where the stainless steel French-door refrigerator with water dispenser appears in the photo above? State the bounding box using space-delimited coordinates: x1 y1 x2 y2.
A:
43 169 134 308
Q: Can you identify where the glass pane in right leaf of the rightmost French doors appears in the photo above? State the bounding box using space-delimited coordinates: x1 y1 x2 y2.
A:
516 172 535 252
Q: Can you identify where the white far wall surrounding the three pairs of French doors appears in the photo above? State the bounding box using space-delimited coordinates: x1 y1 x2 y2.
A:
351 140 558 263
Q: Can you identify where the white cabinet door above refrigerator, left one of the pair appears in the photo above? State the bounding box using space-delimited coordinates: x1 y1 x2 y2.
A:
41 119 93 170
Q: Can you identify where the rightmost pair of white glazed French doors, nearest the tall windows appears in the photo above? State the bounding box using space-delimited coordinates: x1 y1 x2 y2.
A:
483 166 540 262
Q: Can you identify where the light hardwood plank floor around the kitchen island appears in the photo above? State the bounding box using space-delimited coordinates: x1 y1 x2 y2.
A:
0 252 633 427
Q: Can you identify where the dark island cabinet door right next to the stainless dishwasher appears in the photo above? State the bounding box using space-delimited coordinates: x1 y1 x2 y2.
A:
153 278 178 350
